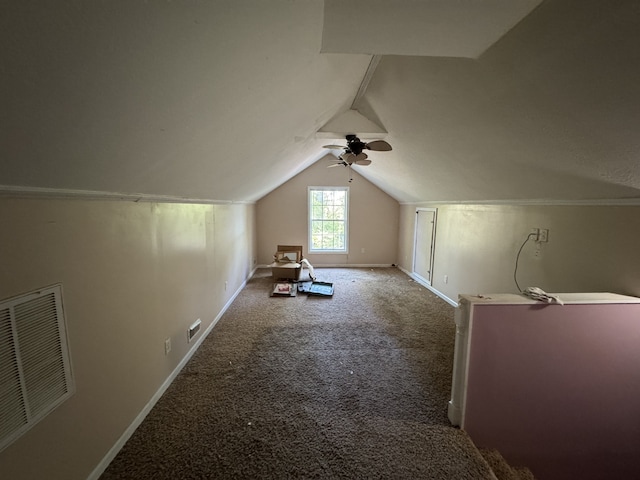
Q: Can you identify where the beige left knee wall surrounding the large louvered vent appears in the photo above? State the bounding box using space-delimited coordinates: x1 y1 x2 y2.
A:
0 199 256 479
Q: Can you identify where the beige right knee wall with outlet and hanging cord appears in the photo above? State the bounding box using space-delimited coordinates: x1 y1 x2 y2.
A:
399 205 640 301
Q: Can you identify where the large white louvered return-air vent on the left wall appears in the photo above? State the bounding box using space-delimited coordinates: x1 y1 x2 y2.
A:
0 285 75 451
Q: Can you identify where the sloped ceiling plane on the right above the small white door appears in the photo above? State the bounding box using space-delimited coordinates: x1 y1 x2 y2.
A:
352 0 640 201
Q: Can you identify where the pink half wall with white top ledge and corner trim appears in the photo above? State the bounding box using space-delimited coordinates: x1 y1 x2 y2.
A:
449 293 640 480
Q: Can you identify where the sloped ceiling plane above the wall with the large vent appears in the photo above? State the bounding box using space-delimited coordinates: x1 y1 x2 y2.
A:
0 0 370 201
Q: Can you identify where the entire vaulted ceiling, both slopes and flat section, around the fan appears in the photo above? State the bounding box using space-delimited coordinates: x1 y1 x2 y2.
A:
0 0 640 202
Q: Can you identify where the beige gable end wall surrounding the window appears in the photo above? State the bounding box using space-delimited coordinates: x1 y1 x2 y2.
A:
256 156 399 266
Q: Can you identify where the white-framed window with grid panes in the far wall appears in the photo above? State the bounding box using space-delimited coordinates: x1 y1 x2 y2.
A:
309 187 349 253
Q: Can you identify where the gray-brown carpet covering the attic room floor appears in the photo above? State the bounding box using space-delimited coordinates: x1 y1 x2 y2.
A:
101 268 492 480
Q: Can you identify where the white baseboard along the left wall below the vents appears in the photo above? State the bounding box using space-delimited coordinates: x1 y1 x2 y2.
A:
87 278 250 480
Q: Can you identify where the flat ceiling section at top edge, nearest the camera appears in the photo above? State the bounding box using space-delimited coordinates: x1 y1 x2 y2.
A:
322 0 542 58
